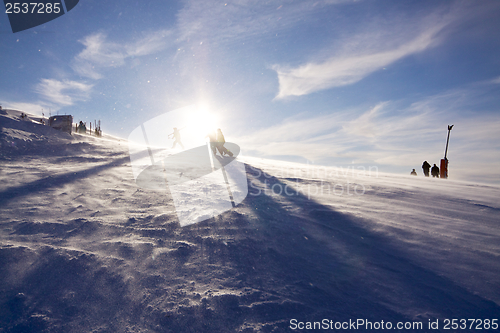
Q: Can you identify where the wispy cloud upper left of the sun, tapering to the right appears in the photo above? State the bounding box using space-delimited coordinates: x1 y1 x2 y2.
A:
72 30 171 80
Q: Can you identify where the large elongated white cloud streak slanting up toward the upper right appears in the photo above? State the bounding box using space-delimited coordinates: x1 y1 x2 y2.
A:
273 8 456 99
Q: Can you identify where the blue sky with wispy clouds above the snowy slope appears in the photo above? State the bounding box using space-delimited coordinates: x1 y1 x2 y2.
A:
0 0 500 183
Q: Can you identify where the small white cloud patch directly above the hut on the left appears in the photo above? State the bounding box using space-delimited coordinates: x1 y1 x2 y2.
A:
35 79 92 106
